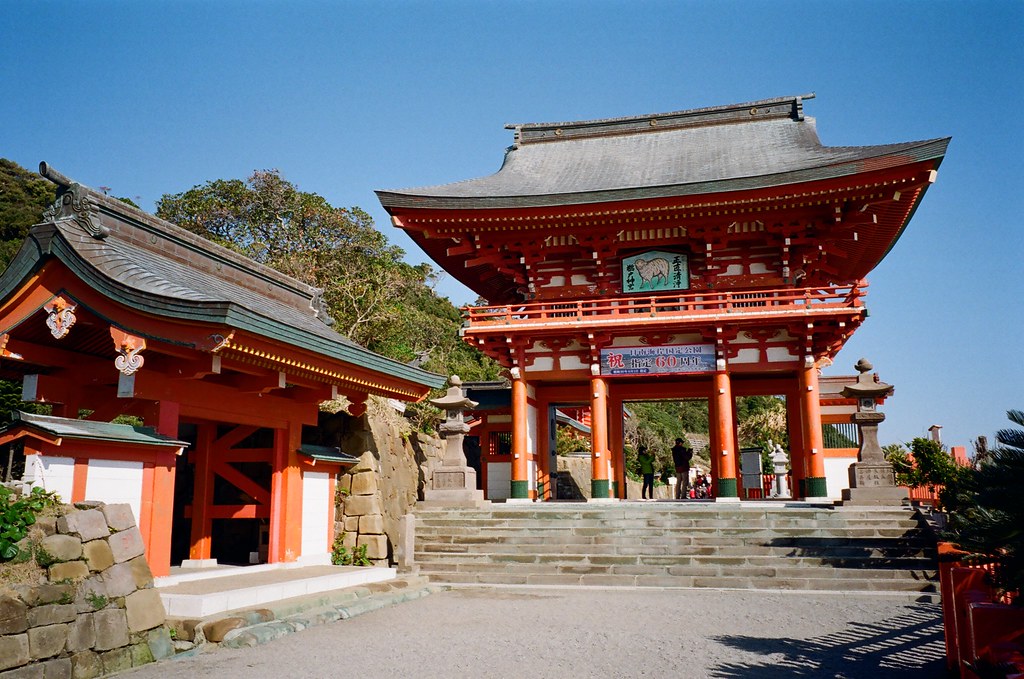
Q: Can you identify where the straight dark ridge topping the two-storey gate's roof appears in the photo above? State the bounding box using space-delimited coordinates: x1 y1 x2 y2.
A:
505 92 815 146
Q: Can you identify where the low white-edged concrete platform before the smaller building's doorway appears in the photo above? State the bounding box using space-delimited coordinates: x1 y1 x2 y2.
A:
155 563 397 619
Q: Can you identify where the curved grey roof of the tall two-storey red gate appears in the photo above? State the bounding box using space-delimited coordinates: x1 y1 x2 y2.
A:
377 94 948 209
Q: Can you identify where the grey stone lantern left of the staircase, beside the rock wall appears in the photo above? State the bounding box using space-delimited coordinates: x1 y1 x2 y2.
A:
423 375 483 507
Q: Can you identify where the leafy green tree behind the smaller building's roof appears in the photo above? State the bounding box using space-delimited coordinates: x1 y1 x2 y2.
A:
157 170 500 419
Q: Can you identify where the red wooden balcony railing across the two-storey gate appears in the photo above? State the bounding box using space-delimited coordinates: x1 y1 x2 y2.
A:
463 282 867 328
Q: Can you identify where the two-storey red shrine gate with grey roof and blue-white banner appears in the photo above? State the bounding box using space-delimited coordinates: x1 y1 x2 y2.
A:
378 95 949 499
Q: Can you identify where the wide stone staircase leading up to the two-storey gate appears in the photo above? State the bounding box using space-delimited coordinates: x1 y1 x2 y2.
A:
415 502 937 592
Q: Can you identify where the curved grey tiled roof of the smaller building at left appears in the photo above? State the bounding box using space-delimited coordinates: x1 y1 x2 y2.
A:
0 164 445 395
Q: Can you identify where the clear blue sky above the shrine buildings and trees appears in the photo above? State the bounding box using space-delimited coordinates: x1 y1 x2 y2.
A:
0 0 1024 454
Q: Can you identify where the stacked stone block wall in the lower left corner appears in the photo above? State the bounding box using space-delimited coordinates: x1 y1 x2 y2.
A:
0 503 174 679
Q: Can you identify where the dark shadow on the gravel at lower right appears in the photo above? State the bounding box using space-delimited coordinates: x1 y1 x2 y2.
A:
709 603 945 679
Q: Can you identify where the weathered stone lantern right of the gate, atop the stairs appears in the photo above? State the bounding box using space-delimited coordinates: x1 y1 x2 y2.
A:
843 358 907 505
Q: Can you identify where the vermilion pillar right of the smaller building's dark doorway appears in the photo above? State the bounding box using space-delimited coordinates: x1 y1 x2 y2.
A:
268 422 302 563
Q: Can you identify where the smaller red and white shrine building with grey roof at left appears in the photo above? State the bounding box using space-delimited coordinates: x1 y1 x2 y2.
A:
0 163 444 576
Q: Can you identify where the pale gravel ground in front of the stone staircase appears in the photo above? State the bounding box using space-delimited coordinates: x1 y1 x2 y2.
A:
119 588 944 679
